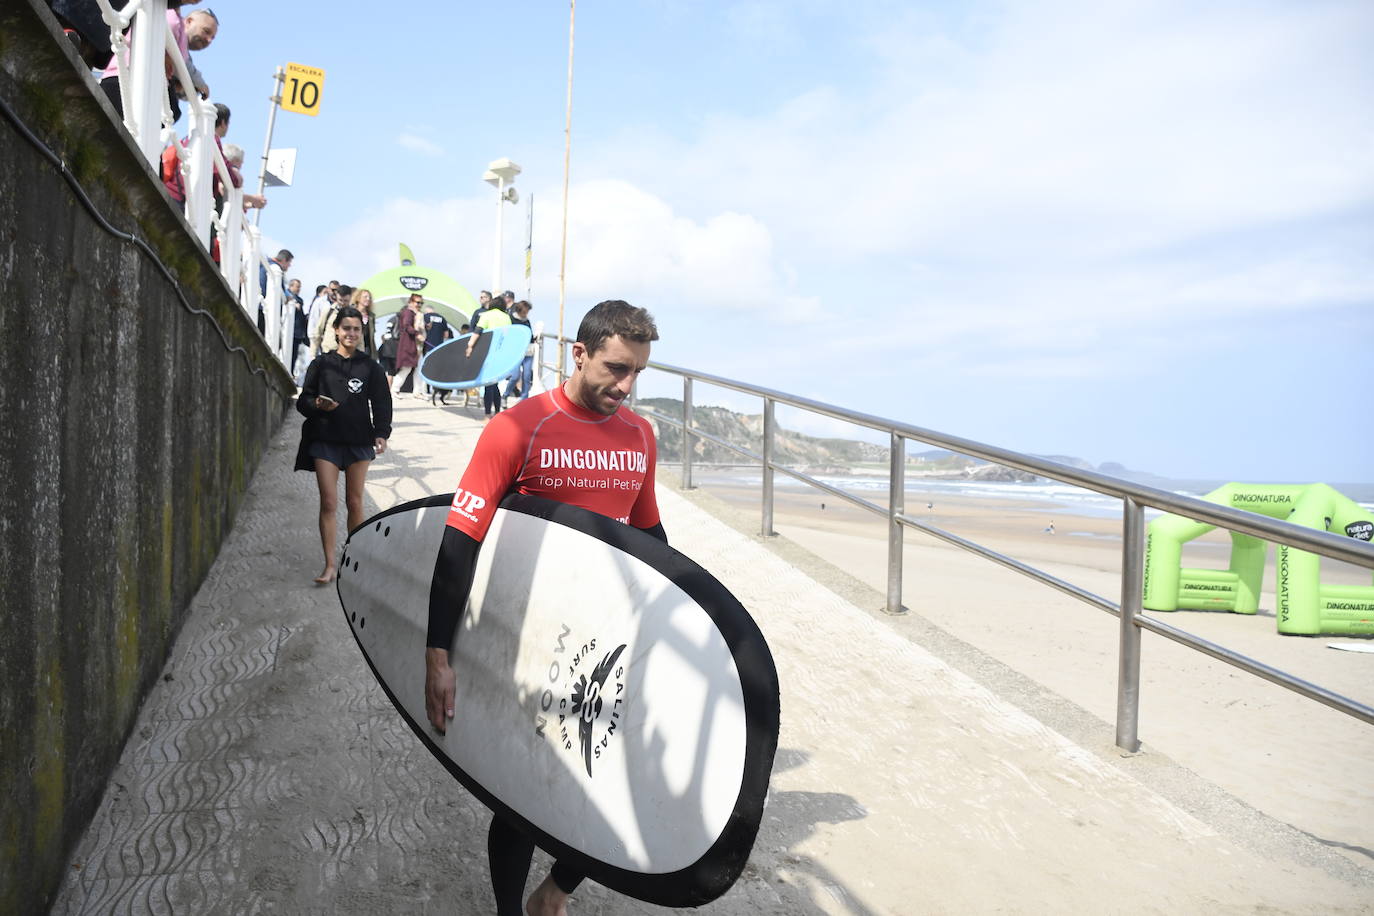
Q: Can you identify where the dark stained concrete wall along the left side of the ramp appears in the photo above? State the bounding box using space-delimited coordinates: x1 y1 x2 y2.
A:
0 0 291 913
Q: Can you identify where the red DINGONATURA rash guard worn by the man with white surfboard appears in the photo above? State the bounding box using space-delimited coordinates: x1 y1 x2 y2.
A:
448 386 658 541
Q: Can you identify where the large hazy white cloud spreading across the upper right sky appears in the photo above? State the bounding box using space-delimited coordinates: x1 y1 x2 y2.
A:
589 1 1374 330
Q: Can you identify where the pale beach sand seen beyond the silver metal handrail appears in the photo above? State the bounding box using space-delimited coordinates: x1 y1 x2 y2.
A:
681 481 1374 867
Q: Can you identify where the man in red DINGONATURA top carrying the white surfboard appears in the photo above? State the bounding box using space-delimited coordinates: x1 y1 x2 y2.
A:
425 299 668 916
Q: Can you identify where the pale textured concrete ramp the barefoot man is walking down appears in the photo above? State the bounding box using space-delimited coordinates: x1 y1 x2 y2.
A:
55 401 1374 916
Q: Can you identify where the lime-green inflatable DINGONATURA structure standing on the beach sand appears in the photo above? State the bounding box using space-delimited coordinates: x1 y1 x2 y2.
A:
1145 483 1374 636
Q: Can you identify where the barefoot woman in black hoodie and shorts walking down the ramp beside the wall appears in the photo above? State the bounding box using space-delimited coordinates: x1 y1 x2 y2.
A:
295 306 392 585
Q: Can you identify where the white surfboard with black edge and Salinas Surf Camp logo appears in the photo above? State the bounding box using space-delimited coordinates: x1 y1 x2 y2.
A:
338 496 779 906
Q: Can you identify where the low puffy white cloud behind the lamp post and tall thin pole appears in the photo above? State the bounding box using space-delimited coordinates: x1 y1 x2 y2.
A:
298 181 816 321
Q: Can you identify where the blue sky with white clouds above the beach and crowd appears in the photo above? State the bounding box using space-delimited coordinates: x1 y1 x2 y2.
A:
195 0 1374 483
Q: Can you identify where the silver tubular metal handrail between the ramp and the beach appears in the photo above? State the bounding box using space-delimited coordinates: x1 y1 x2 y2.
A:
539 335 1374 753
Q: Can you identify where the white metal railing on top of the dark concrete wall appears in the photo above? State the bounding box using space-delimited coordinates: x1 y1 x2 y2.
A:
96 0 295 372
